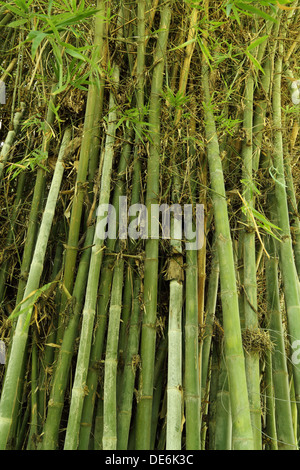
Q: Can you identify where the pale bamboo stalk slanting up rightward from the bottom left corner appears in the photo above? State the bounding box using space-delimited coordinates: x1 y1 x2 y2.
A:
0 128 71 449
